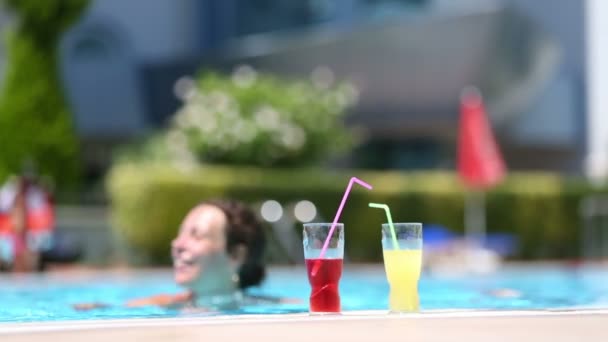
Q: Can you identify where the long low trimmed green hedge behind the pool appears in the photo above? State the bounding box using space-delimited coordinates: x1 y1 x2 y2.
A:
107 164 591 262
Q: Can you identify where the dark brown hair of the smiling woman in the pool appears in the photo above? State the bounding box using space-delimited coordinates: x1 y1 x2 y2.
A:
202 200 266 289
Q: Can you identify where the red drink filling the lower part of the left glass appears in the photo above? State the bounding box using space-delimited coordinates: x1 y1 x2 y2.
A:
306 259 342 312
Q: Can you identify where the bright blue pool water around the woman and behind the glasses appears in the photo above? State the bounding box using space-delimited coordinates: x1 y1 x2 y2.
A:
0 265 608 322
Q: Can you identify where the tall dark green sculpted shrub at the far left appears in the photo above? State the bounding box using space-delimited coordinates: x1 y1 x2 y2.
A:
0 0 88 184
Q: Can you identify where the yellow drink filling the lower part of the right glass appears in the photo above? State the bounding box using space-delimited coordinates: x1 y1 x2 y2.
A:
383 249 422 312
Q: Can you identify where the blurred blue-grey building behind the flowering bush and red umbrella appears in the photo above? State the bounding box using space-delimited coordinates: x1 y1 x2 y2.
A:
0 0 591 179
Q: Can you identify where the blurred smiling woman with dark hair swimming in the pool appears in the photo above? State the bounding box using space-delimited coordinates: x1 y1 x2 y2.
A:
74 200 281 310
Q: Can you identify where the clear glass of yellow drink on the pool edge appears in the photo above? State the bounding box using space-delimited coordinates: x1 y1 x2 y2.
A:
382 223 422 313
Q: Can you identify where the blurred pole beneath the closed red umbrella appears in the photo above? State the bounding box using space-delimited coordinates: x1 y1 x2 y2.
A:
464 190 486 247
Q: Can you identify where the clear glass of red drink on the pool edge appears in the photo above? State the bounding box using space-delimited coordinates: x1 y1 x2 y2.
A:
303 223 344 314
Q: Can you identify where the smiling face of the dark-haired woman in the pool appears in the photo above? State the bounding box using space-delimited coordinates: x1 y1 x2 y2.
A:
171 204 231 286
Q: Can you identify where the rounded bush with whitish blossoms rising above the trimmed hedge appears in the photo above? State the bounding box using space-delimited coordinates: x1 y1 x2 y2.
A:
120 66 357 166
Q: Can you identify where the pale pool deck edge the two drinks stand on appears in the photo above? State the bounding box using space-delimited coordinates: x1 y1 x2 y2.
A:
0 310 608 342
